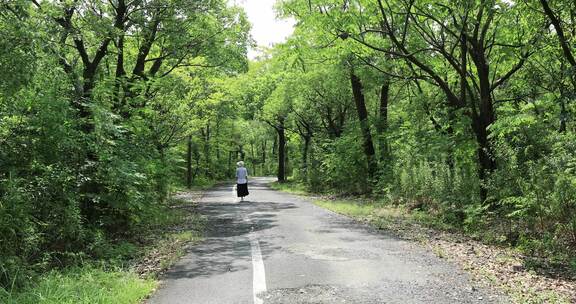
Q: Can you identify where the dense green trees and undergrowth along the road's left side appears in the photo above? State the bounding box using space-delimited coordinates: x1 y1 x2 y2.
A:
0 0 250 288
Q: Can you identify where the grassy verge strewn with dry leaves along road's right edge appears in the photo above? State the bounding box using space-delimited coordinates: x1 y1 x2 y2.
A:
272 183 576 304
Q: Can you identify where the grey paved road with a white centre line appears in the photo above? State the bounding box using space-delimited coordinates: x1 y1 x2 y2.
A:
149 178 504 304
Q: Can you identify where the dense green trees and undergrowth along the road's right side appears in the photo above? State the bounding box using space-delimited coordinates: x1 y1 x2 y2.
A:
231 0 576 258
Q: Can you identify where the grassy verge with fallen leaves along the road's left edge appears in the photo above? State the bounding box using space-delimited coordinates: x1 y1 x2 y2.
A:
0 190 209 304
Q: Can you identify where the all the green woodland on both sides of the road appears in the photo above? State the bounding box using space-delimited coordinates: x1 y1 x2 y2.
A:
0 0 576 292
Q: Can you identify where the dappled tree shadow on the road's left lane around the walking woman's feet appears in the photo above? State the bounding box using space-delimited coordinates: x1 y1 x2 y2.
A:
165 181 297 279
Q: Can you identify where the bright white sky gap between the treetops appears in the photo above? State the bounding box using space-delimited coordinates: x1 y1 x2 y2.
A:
233 0 295 59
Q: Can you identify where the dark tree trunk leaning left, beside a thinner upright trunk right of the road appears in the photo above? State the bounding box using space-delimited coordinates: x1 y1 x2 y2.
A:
350 71 376 178
